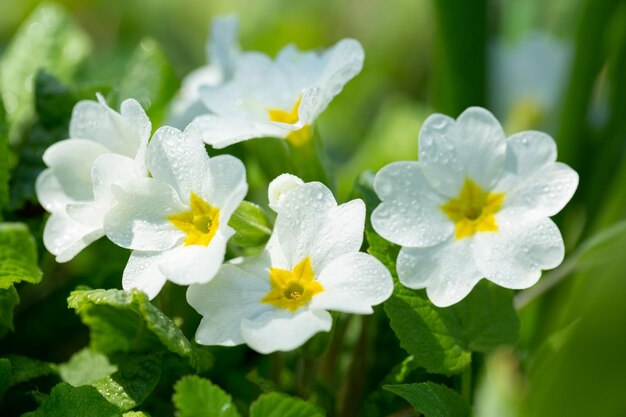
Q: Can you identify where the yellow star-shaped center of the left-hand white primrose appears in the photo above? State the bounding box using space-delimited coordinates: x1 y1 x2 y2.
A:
167 192 220 246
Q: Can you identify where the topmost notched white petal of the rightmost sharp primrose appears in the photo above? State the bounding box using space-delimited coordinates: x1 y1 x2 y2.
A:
419 107 506 197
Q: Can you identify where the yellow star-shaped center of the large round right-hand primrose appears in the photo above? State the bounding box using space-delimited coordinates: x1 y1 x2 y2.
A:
441 178 504 239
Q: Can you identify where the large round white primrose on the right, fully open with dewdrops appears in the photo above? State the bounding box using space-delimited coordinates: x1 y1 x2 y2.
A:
372 107 578 307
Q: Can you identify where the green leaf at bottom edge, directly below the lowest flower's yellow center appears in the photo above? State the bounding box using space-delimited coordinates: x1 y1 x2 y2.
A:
250 392 325 417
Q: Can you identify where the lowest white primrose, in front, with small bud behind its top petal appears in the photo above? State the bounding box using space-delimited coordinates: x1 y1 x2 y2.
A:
187 182 393 353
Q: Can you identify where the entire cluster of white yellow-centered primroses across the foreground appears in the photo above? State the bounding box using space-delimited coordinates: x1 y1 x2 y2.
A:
36 18 578 353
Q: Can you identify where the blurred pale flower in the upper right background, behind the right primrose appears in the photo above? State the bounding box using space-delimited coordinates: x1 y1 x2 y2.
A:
489 32 572 132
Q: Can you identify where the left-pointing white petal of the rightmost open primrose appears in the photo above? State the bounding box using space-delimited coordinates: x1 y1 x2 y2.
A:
372 162 454 247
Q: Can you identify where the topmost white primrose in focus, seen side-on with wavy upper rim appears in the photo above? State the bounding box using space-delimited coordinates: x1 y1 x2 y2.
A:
191 39 364 148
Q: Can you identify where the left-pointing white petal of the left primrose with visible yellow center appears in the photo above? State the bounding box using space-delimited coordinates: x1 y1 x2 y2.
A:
104 178 188 251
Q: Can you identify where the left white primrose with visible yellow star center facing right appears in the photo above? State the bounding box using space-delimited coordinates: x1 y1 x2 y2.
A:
104 126 248 298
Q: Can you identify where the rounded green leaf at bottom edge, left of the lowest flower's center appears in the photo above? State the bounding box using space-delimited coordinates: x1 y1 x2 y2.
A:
173 375 240 417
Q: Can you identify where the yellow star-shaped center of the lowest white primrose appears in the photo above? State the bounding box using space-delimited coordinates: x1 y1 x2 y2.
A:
261 256 324 311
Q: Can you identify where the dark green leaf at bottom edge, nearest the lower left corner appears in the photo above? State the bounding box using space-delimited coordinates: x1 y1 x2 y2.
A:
29 382 122 417
